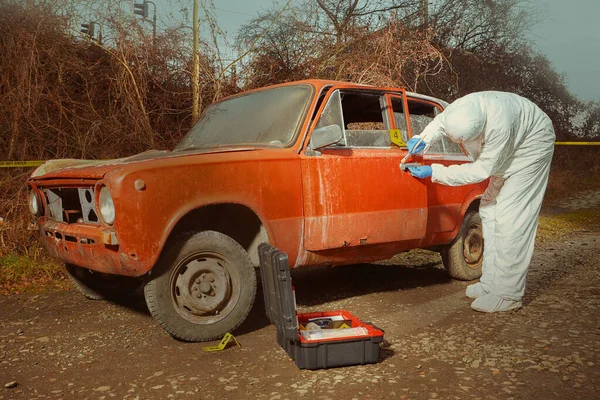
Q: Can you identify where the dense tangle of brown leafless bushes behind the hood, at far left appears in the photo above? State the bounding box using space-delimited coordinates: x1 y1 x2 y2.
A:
0 0 233 253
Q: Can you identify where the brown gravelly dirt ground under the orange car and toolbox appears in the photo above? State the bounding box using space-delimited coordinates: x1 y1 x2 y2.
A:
0 198 600 400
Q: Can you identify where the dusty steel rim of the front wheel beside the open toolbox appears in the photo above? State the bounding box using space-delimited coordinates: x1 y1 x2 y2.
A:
170 251 241 325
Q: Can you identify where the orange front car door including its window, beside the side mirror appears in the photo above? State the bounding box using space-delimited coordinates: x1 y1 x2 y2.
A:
301 86 427 251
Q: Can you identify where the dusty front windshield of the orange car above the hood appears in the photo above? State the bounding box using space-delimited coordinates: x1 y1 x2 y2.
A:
174 85 312 151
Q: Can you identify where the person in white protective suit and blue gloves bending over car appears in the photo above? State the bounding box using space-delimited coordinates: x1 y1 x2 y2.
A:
408 92 555 312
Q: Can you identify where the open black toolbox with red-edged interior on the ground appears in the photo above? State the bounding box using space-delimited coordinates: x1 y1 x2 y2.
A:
259 243 384 369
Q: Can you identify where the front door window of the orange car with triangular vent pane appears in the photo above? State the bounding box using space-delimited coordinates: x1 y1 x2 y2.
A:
316 90 392 148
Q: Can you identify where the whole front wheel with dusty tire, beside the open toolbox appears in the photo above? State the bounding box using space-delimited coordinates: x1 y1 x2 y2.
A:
144 231 256 342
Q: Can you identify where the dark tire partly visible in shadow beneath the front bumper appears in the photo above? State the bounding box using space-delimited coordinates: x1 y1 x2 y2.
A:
65 264 142 300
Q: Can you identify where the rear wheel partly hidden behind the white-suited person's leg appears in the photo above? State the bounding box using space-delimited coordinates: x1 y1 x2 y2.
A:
441 211 484 281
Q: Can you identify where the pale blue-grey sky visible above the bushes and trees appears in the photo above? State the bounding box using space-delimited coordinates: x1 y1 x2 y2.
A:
157 0 600 101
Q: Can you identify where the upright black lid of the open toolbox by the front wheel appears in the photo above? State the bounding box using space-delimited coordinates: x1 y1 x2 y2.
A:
258 243 298 342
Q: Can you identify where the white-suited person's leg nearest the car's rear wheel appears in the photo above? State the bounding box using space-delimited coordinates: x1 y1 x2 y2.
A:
465 176 504 299
